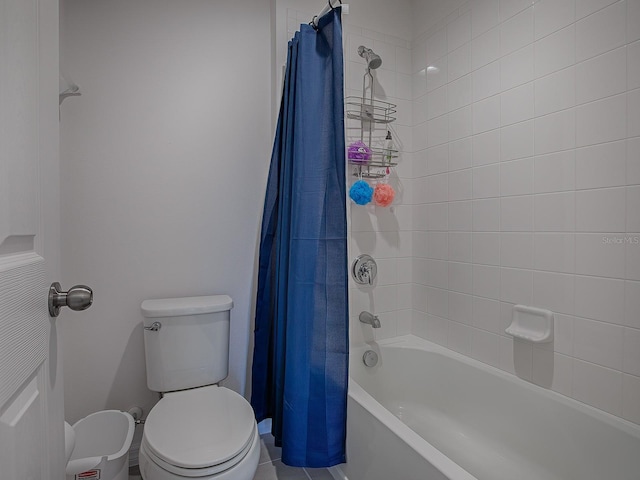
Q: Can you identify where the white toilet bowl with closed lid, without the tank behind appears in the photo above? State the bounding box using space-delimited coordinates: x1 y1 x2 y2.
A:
139 385 260 480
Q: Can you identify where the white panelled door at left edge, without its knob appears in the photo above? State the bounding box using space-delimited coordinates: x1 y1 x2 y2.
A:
0 0 65 480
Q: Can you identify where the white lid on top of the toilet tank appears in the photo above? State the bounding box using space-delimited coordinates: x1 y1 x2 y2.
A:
140 295 233 318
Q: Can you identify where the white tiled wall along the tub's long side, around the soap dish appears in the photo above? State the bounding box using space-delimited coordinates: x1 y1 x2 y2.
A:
412 0 640 423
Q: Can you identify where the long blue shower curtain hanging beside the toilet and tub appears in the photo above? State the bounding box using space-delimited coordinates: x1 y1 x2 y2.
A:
251 8 349 467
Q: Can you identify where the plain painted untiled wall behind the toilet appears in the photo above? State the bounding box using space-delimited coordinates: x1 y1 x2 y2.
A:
59 0 272 421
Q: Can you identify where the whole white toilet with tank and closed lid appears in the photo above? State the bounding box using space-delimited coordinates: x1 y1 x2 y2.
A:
139 295 260 480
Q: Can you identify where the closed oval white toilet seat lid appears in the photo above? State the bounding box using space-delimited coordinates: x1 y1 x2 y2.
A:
144 385 255 468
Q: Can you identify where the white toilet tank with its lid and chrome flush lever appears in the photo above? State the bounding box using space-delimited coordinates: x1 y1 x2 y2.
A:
141 295 233 392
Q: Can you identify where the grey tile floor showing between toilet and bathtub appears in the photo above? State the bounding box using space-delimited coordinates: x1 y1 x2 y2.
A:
129 433 333 480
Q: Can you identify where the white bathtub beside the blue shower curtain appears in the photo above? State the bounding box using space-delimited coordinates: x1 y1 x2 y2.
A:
331 335 640 480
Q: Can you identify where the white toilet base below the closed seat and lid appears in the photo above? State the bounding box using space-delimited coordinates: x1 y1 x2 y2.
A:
139 424 260 480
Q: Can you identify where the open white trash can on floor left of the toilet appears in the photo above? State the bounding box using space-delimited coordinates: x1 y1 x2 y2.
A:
66 410 135 480
